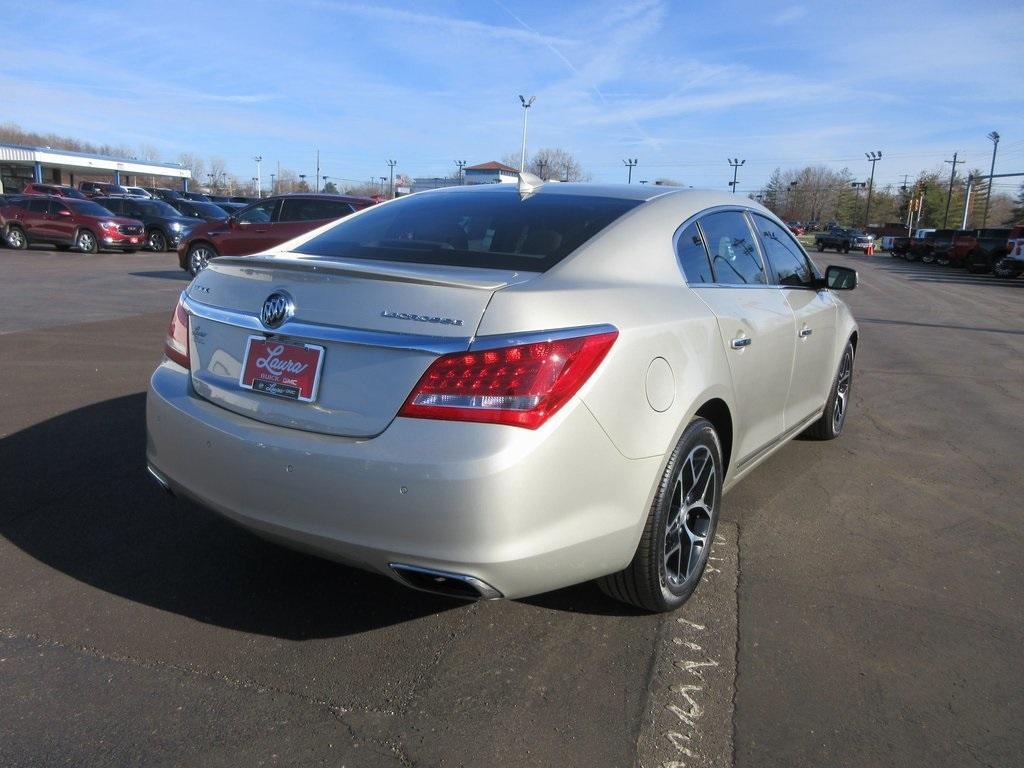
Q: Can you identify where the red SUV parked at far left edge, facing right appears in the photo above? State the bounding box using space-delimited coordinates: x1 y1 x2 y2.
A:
0 195 145 253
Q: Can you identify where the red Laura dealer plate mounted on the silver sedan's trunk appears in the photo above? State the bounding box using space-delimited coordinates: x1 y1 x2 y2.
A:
239 336 324 402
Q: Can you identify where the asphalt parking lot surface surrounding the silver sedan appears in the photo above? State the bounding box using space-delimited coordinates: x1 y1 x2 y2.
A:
0 244 1024 768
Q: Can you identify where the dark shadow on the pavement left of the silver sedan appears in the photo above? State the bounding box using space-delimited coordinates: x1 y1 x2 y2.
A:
0 392 465 640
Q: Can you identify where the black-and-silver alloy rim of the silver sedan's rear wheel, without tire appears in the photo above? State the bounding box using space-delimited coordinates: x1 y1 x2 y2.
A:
665 445 717 588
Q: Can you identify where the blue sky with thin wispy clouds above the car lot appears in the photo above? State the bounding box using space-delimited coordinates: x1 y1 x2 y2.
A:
0 0 1024 191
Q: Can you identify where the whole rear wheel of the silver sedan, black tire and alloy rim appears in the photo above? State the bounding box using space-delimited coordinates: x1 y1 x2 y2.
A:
598 418 723 612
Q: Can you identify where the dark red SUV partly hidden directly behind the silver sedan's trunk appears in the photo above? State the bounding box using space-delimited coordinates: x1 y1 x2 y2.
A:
178 194 375 275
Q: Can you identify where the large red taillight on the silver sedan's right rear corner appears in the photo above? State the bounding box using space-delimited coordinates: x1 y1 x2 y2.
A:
398 331 618 429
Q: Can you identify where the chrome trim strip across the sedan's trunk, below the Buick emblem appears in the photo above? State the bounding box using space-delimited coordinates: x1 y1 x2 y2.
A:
181 295 472 355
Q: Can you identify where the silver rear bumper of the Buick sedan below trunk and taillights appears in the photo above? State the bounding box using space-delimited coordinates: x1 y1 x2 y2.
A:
146 361 663 597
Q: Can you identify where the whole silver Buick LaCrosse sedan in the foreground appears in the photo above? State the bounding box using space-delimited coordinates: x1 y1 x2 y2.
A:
146 176 857 611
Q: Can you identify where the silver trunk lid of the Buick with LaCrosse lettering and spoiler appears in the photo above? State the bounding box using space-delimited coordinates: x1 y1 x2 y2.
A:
186 254 535 437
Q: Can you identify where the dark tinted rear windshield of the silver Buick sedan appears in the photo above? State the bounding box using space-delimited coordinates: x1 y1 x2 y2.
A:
295 184 641 272
